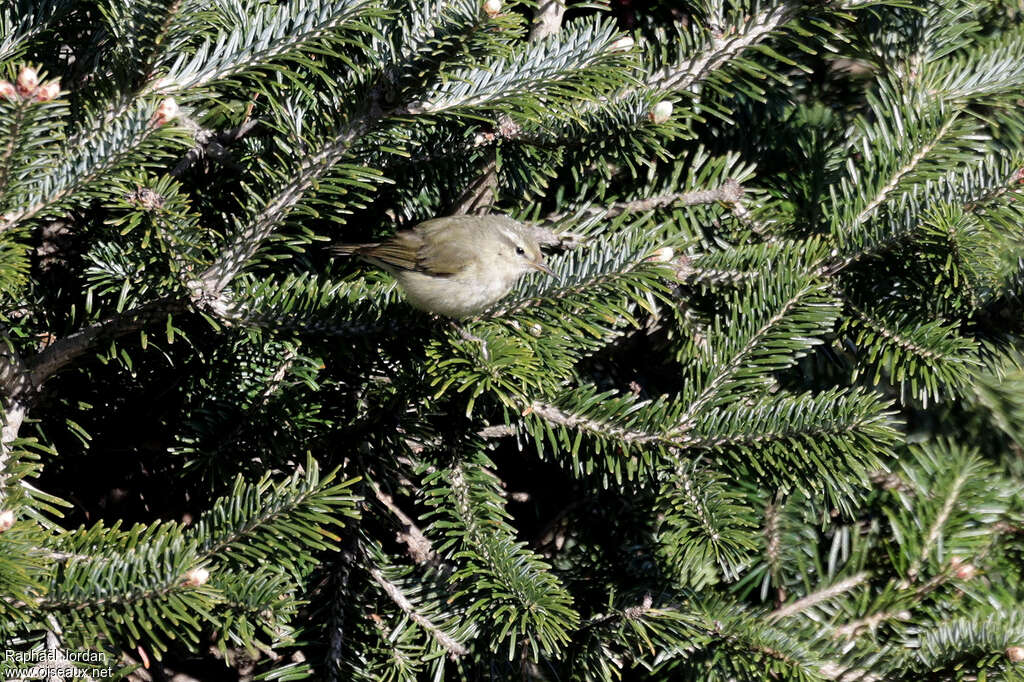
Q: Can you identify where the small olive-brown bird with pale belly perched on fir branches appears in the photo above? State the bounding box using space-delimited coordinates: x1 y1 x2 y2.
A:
331 214 555 318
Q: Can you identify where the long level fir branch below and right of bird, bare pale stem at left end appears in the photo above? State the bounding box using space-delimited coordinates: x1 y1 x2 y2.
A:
524 388 898 501
